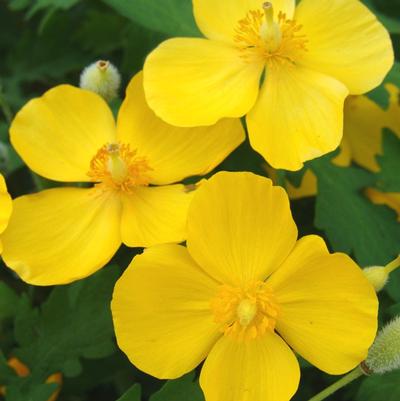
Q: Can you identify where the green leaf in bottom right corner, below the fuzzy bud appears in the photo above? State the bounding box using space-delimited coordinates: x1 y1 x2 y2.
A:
356 370 400 401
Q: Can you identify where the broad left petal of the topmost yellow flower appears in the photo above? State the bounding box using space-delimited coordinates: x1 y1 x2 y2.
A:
144 38 264 127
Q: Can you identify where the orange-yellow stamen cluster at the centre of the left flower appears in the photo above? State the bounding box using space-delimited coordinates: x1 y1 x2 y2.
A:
88 143 152 192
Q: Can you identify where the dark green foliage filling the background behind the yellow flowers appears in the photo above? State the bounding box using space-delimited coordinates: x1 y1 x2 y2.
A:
0 0 400 401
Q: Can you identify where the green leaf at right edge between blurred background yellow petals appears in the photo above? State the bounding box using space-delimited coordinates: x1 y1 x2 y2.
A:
377 130 400 192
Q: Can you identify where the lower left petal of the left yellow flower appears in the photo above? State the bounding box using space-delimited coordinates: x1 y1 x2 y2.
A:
2 188 121 285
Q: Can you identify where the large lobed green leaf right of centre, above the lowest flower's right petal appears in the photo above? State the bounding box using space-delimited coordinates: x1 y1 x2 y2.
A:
310 157 400 266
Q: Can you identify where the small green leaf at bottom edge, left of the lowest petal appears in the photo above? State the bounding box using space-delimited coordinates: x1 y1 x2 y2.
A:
150 372 204 401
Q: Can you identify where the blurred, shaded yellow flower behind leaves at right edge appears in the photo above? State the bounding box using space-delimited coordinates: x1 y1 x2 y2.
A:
274 84 400 221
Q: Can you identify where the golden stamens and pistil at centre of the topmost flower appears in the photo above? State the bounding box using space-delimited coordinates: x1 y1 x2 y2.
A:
234 2 307 65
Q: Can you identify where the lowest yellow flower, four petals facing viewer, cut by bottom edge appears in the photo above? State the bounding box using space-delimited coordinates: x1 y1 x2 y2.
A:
111 172 378 401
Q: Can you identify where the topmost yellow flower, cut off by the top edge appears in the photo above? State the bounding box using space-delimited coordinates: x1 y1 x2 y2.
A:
144 0 394 170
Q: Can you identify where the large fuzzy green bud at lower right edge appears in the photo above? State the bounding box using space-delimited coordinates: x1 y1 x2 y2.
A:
364 316 400 374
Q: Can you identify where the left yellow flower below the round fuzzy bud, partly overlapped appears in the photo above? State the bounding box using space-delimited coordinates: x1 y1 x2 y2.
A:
3 74 244 285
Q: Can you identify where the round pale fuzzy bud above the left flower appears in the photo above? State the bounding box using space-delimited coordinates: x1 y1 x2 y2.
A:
80 60 121 102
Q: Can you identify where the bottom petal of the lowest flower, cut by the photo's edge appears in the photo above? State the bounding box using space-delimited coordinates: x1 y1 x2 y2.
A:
200 332 300 401
